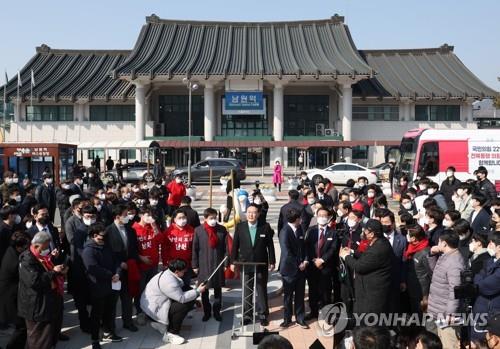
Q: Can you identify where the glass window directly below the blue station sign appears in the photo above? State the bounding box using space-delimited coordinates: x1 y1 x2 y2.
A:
222 115 268 137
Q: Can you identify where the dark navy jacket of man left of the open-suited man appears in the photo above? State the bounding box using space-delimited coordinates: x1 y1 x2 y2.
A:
82 240 120 298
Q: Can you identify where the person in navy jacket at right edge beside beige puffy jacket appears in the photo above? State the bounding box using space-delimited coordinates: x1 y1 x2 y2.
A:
471 231 500 339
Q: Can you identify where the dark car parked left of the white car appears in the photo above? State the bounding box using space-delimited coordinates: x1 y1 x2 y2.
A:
171 158 246 183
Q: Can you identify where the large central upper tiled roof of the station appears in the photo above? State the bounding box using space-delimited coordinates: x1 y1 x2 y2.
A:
114 15 373 79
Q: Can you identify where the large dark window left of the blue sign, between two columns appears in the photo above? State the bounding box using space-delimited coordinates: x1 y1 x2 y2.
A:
159 96 204 137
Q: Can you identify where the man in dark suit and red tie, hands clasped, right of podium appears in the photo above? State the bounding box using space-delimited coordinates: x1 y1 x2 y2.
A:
305 208 339 320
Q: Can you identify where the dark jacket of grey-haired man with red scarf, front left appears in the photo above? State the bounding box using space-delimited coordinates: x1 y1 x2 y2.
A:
17 249 61 322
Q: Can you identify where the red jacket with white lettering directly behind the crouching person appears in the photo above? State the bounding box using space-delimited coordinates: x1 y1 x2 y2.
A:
161 223 194 267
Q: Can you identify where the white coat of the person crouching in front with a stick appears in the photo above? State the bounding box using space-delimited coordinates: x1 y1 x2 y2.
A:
141 269 198 325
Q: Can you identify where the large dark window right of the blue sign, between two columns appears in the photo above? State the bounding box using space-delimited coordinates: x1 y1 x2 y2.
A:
284 95 330 136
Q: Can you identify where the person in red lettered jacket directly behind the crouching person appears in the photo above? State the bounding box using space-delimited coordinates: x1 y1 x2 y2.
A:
161 210 194 286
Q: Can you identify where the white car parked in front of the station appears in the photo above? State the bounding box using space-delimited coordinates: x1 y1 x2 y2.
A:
306 162 377 184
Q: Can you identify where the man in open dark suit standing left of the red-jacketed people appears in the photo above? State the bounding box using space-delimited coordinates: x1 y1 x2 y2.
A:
106 204 139 333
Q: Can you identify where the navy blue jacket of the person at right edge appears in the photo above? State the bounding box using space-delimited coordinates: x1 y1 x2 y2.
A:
473 258 500 314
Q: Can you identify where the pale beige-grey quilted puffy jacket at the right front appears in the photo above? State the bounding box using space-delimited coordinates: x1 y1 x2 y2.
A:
428 250 465 318
